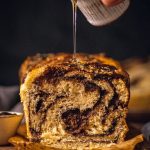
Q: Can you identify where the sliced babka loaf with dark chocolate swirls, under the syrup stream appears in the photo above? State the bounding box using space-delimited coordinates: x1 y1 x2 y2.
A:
20 53 130 149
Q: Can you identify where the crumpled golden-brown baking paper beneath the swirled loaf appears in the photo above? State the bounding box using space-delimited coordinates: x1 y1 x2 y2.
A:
9 125 143 150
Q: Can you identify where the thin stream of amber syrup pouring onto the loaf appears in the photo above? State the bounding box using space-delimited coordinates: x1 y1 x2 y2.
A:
71 0 77 60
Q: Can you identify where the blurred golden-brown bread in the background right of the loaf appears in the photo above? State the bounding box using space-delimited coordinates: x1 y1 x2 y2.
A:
124 57 150 121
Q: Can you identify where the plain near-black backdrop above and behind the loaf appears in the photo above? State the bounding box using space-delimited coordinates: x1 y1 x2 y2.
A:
0 0 150 85
